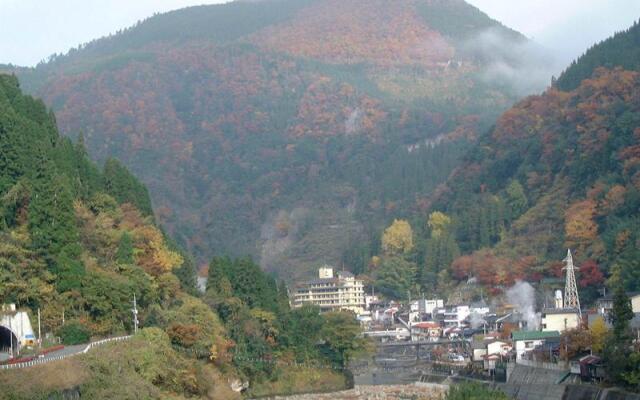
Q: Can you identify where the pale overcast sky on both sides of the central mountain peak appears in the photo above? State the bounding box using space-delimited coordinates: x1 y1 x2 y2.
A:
0 0 640 65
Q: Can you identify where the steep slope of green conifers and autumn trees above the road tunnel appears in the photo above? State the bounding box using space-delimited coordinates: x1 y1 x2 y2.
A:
0 75 193 328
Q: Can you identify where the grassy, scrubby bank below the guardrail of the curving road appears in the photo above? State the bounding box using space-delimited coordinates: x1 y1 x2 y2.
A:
0 329 240 400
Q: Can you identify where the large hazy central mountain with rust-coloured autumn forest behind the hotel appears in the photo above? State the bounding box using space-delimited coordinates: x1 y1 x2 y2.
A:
3 0 546 279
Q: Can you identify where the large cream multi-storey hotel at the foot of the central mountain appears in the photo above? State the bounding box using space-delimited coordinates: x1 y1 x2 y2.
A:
293 265 365 314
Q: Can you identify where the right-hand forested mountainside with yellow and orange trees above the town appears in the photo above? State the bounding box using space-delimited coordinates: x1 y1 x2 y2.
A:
369 24 640 305
